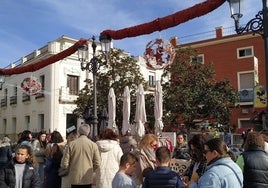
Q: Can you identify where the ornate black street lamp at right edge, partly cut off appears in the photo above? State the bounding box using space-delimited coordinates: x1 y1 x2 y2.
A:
228 0 268 129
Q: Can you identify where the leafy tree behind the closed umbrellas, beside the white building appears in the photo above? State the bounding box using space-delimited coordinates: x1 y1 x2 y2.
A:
74 49 147 133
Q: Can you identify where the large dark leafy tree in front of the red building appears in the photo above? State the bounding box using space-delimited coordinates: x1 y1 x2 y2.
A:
162 48 238 129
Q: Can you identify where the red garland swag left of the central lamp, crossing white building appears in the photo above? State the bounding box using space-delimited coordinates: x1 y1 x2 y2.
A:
0 39 87 75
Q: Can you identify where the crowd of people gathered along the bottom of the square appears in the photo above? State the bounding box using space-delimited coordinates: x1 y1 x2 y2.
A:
0 124 268 188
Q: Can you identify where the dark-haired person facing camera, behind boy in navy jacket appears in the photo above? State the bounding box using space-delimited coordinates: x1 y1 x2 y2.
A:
172 132 191 160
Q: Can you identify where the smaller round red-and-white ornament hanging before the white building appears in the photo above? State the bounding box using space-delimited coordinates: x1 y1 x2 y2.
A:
20 77 42 95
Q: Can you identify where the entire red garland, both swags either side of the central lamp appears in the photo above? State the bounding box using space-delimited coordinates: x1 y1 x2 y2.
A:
0 0 226 75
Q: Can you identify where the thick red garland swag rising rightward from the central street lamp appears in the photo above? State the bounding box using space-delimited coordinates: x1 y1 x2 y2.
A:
101 0 226 40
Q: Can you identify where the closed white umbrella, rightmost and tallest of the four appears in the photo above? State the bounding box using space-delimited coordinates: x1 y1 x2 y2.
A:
154 81 164 135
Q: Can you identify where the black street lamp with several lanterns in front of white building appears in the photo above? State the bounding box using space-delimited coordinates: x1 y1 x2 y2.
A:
78 35 111 138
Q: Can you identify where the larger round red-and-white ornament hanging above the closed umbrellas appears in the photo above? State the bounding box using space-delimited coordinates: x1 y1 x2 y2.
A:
144 39 175 69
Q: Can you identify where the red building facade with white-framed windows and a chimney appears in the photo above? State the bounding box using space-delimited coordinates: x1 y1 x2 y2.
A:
180 27 266 131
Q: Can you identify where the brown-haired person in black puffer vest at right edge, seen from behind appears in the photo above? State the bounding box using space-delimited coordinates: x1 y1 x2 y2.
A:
237 132 268 188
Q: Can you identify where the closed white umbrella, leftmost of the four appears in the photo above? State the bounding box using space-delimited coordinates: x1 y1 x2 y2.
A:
108 88 116 130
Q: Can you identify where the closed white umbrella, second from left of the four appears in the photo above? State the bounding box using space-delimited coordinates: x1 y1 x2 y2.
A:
122 86 130 135
